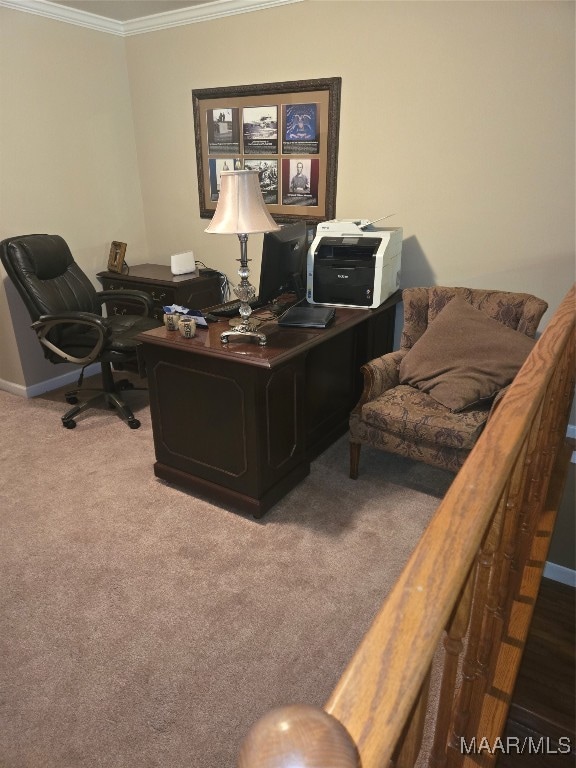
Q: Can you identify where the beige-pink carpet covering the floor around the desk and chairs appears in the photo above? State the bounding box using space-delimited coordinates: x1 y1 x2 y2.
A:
0 376 452 768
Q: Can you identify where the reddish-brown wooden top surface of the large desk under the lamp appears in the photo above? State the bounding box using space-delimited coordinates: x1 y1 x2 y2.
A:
137 291 401 368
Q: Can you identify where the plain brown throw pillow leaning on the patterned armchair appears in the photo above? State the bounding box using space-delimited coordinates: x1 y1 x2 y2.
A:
400 298 535 411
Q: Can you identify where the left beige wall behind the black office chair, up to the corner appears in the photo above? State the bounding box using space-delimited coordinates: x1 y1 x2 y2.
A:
0 7 147 388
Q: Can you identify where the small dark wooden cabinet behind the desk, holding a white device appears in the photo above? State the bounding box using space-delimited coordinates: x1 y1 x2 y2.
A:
97 264 222 320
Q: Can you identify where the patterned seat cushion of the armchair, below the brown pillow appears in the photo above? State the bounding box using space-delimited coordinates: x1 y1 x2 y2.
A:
361 384 490 450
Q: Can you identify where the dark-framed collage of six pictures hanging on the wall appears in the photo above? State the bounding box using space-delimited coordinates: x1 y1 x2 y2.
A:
192 77 342 224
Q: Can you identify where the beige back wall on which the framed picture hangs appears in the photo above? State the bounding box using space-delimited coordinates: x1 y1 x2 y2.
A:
126 1 575 320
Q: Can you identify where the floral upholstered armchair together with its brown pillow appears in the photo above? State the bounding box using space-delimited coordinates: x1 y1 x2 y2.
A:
350 286 548 479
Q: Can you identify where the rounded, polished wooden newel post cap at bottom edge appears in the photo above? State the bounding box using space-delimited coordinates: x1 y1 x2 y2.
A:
238 705 360 768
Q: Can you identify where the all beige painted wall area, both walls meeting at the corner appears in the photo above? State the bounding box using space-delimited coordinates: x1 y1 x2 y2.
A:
0 0 575 385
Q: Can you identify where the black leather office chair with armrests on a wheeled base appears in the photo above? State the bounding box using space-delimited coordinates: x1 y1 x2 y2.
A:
0 235 161 429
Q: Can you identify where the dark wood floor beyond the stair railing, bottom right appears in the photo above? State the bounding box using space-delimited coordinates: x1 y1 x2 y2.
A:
497 579 576 768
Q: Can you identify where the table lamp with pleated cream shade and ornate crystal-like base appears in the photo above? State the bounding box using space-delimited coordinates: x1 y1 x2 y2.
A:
205 171 280 346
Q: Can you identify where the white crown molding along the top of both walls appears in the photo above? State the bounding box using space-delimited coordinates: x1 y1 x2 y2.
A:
0 0 304 37
